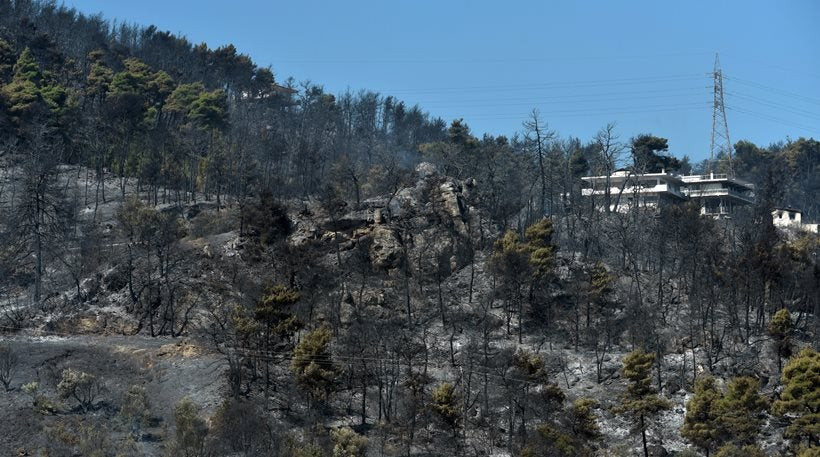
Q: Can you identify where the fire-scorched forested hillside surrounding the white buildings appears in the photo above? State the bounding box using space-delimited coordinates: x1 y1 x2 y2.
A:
0 0 820 457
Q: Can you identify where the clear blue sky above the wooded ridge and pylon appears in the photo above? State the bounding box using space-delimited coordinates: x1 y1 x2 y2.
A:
60 0 820 160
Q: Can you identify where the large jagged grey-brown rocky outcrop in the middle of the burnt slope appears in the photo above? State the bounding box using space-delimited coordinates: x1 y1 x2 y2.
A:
291 163 493 276
